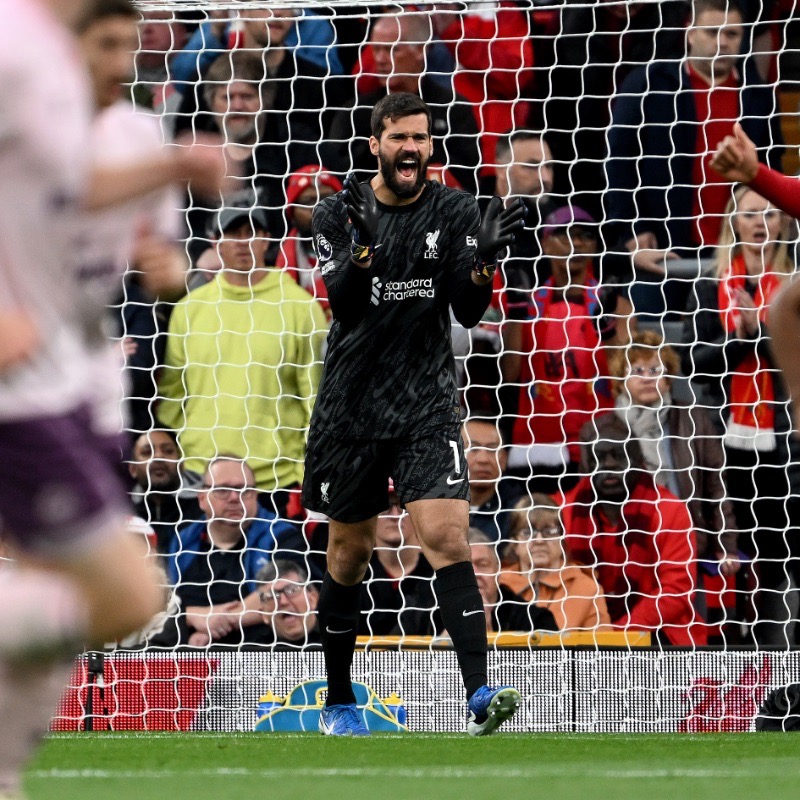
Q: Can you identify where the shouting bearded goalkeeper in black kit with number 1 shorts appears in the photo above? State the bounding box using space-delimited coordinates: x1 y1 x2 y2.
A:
303 93 524 736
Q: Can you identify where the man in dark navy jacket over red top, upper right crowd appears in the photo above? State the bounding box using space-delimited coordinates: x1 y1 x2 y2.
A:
605 0 783 313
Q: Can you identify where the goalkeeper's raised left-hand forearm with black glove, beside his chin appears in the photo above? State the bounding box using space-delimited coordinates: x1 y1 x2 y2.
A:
311 177 377 328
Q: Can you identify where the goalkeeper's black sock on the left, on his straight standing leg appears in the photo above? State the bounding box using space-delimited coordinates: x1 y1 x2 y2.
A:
317 572 361 706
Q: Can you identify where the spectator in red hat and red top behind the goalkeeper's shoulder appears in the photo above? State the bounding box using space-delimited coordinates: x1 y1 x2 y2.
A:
275 164 342 319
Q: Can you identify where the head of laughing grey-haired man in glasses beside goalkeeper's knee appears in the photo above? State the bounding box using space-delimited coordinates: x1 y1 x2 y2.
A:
256 558 320 650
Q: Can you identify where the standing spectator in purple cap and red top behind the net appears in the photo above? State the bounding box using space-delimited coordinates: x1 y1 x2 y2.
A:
502 206 630 493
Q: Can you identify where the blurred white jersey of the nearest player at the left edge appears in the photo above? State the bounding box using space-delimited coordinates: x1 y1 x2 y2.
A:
0 0 91 420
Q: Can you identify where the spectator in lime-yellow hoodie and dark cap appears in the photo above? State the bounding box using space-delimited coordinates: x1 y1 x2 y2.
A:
157 200 327 493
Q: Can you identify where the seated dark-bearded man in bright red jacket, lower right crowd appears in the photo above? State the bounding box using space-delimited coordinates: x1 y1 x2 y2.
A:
562 414 706 646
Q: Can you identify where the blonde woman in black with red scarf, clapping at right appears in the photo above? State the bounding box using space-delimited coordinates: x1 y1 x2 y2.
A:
683 186 800 645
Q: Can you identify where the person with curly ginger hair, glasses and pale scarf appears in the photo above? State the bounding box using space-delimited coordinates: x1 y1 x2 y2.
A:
610 331 740 576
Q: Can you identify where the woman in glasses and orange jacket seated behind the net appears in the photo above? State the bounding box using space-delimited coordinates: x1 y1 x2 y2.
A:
500 493 611 631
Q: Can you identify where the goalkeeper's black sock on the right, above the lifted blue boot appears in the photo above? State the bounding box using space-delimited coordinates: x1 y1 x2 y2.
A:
433 561 488 699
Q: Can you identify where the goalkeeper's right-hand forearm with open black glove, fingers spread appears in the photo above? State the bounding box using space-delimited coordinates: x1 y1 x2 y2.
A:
448 197 525 328
